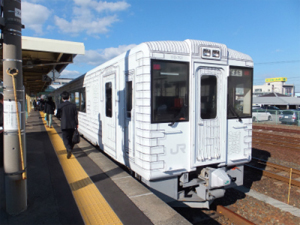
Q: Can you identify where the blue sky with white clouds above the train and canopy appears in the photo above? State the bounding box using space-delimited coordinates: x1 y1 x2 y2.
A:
22 0 300 92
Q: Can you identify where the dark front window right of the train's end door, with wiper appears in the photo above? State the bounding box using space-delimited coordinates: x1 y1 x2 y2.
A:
227 67 253 119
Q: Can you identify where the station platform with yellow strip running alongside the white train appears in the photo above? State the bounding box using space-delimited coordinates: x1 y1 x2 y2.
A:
0 111 190 225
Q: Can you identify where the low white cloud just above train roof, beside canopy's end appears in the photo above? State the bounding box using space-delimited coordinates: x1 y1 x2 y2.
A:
74 44 136 66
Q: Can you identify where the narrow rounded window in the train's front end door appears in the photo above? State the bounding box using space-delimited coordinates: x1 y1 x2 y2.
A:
200 75 217 119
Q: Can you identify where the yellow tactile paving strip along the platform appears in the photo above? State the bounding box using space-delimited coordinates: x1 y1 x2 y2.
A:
40 112 122 224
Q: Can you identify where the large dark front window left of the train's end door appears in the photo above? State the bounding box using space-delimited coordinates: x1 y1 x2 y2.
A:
151 60 189 124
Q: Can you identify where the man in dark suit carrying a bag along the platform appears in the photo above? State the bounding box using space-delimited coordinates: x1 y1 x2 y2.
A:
56 91 78 159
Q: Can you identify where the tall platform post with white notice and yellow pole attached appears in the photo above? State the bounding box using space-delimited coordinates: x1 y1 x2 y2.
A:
3 0 27 215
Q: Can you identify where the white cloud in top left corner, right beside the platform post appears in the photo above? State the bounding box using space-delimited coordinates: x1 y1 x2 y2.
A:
22 1 51 34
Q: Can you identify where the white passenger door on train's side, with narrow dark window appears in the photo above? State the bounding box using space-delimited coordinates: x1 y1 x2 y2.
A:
102 74 117 157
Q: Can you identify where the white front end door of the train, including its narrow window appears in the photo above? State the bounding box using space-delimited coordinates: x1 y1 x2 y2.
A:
194 67 226 165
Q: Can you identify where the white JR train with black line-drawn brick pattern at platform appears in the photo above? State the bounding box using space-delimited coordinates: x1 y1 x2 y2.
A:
52 40 253 208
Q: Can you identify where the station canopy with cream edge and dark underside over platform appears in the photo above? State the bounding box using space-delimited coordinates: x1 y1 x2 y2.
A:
0 36 85 94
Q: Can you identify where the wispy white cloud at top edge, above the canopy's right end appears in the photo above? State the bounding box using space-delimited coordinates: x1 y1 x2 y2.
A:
54 0 130 35
